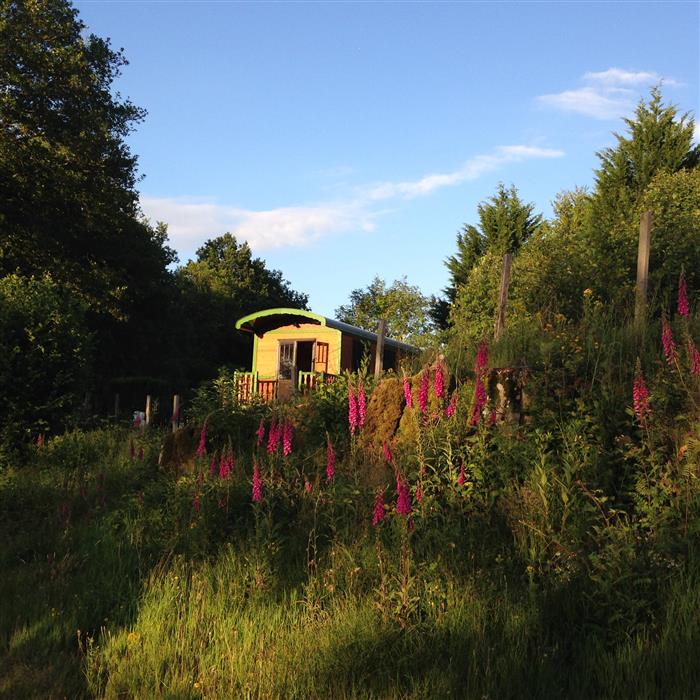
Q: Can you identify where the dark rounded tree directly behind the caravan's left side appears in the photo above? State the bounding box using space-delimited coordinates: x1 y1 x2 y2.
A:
176 233 308 380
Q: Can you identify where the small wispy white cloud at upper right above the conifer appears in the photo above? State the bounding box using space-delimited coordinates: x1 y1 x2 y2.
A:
537 68 679 119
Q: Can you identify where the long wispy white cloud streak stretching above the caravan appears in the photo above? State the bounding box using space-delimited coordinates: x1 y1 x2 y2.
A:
141 145 564 251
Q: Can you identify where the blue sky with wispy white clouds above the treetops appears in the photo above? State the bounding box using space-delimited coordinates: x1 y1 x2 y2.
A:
75 0 700 316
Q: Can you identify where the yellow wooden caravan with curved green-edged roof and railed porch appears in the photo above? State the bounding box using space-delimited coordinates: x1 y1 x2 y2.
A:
236 309 420 401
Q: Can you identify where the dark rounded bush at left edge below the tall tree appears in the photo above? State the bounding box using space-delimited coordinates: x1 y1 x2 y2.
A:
0 275 92 450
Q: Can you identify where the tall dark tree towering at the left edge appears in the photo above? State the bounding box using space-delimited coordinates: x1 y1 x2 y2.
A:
0 0 175 388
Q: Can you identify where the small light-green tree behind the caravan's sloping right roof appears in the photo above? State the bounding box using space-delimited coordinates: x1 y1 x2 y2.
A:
335 277 433 347
